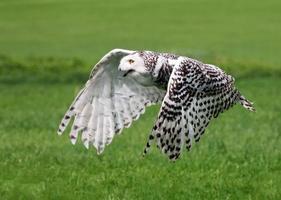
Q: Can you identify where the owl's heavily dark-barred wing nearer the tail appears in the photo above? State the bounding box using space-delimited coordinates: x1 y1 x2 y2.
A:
144 57 240 160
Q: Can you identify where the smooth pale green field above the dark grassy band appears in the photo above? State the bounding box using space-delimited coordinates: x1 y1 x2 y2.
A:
0 0 281 67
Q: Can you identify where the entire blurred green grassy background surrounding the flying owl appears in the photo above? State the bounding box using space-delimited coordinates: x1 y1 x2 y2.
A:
0 0 281 199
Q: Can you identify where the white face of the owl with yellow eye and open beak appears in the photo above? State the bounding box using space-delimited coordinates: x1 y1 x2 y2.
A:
118 53 149 76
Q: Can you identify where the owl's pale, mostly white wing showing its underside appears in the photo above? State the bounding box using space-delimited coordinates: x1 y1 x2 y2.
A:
58 49 165 153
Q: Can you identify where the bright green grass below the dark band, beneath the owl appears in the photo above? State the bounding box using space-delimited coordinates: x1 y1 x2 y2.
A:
0 78 281 199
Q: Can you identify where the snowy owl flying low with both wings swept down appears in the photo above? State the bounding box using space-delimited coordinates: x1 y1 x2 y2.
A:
58 49 255 161
